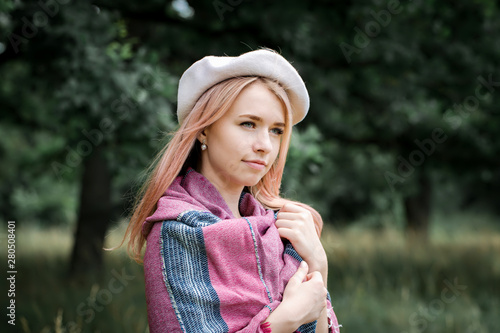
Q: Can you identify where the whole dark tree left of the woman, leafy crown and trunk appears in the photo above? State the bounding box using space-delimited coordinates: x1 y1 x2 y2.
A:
0 2 178 276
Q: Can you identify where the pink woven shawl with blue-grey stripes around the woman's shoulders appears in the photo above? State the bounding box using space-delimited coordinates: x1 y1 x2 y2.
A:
143 169 338 333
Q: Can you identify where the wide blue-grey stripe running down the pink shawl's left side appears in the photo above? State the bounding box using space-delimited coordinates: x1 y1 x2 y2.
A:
160 212 228 332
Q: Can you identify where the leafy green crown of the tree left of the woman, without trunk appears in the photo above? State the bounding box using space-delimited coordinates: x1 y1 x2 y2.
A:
0 2 176 224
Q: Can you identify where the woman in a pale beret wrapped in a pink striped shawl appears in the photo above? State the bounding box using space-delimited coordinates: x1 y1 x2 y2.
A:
126 50 339 333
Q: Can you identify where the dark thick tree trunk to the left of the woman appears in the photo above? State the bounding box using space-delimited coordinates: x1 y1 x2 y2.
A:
70 147 112 278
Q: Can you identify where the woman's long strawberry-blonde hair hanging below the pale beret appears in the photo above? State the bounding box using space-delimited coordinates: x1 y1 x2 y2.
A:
121 76 323 263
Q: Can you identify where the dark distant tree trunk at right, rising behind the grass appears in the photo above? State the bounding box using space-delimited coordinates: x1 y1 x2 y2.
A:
404 172 431 243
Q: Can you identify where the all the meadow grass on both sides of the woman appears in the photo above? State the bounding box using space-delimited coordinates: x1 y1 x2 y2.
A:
0 211 500 333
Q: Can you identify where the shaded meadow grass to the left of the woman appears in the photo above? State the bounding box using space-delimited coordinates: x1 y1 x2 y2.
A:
0 228 147 333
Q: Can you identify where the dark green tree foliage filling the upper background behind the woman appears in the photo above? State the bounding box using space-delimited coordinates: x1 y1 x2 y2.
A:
0 0 500 223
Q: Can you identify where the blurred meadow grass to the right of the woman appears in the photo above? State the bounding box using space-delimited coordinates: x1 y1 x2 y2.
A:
323 211 500 333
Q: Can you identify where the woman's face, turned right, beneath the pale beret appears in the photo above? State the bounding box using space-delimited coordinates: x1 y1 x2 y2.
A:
198 82 285 193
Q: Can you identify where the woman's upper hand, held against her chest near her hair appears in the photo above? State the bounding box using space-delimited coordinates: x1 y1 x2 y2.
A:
276 203 328 274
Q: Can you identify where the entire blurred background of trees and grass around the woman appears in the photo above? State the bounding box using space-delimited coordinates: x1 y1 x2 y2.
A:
0 0 500 333
